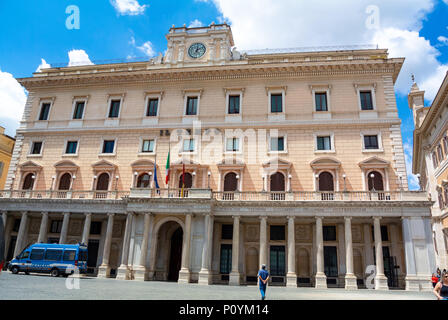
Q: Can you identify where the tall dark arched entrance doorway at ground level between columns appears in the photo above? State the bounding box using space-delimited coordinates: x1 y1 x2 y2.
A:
155 221 183 281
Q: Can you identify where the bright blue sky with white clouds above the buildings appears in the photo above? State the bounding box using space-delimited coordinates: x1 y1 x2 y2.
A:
0 0 448 189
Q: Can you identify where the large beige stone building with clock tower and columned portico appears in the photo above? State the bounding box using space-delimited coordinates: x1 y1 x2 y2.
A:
0 24 435 290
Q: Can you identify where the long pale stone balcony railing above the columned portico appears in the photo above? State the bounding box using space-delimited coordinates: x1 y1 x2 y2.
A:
0 189 428 202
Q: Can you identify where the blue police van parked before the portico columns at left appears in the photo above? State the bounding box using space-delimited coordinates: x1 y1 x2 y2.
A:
8 243 87 277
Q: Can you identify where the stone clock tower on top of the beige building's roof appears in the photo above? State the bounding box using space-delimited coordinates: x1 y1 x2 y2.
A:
164 23 234 67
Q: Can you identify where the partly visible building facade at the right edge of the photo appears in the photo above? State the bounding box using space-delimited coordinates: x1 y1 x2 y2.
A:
409 75 448 270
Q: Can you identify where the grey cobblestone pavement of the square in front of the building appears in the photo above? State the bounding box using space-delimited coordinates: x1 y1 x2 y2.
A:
0 272 435 300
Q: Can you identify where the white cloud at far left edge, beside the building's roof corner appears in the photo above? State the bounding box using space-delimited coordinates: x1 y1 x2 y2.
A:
0 70 27 136
